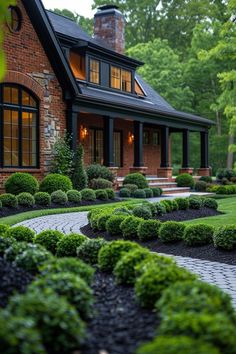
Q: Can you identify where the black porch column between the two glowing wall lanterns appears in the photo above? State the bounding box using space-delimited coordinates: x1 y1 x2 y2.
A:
103 116 114 167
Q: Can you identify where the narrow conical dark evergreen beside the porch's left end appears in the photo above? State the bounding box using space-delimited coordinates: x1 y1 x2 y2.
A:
71 144 88 191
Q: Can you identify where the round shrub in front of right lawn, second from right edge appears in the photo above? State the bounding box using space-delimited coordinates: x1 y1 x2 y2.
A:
183 224 214 246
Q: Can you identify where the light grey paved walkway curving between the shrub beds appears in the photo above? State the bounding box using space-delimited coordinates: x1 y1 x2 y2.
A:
18 212 236 308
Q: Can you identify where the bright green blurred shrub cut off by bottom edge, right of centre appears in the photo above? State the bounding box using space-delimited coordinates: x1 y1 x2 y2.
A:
137 335 220 354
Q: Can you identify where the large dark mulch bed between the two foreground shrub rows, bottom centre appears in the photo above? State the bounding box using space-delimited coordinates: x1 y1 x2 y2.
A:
81 271 159 354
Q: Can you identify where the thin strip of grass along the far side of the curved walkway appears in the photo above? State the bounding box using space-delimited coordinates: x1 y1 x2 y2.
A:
0 199 137 225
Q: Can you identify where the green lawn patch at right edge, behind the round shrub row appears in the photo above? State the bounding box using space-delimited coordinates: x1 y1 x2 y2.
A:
185 197 236 226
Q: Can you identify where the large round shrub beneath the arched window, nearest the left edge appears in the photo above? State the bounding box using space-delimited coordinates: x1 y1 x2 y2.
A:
5 172 39 195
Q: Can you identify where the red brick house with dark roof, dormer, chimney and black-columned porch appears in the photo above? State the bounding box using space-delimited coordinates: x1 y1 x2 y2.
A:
0 0 212 188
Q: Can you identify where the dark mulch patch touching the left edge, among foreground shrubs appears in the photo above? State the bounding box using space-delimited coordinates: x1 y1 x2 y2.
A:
0 258 33 307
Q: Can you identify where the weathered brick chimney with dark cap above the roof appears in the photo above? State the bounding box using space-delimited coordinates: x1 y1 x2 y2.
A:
94 5 125 54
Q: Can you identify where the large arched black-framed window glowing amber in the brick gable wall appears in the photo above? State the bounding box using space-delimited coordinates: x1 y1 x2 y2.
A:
0 85 38 168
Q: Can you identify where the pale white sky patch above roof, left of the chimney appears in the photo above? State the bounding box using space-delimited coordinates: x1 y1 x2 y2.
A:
42 0 94 17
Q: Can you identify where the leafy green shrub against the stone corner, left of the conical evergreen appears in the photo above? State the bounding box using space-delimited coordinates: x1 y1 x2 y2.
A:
50 134 74 177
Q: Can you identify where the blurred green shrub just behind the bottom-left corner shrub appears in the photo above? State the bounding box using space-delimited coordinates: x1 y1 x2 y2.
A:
8 289 85 354
